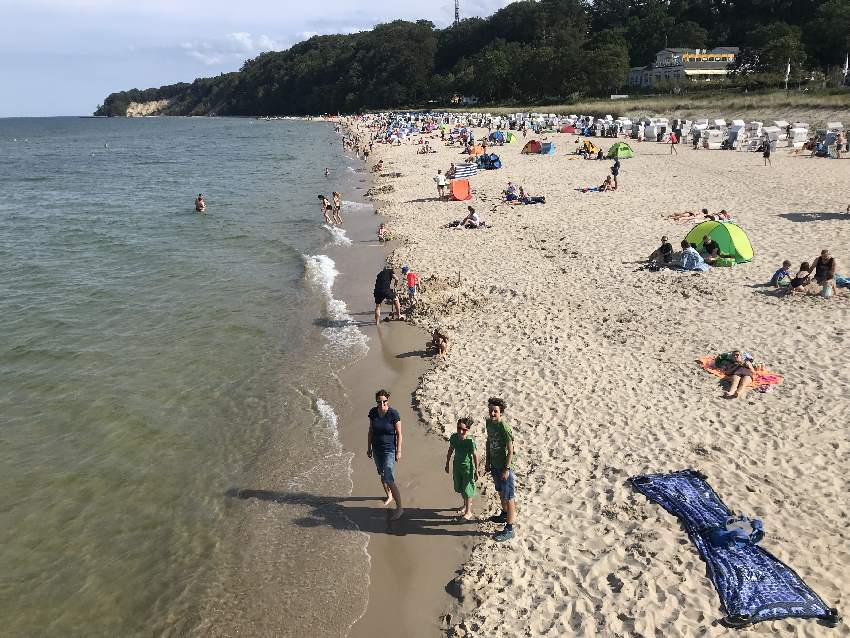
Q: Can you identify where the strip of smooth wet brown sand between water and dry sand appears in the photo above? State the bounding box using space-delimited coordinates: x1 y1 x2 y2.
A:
326 146 476 638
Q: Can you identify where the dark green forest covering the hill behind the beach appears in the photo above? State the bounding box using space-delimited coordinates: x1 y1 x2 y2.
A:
95 0 850 115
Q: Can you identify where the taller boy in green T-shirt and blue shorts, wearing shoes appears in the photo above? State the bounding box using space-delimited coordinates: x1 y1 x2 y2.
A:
485 397 516 543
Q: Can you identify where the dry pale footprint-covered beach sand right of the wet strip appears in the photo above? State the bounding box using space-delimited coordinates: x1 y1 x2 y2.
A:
364 129 850 637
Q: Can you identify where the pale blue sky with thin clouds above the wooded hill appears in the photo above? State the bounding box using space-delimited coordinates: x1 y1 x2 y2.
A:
0 0 511 117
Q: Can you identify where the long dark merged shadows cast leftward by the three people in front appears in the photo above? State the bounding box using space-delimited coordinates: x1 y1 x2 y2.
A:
225 487 483 536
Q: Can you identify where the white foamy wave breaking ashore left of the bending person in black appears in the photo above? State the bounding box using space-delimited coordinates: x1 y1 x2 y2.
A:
304 255 369 356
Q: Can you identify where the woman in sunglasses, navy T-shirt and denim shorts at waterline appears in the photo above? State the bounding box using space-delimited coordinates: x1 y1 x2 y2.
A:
366 389 404 521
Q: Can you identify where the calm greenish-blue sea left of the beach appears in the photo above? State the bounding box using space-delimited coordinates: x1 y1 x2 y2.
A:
0 118 378 637
